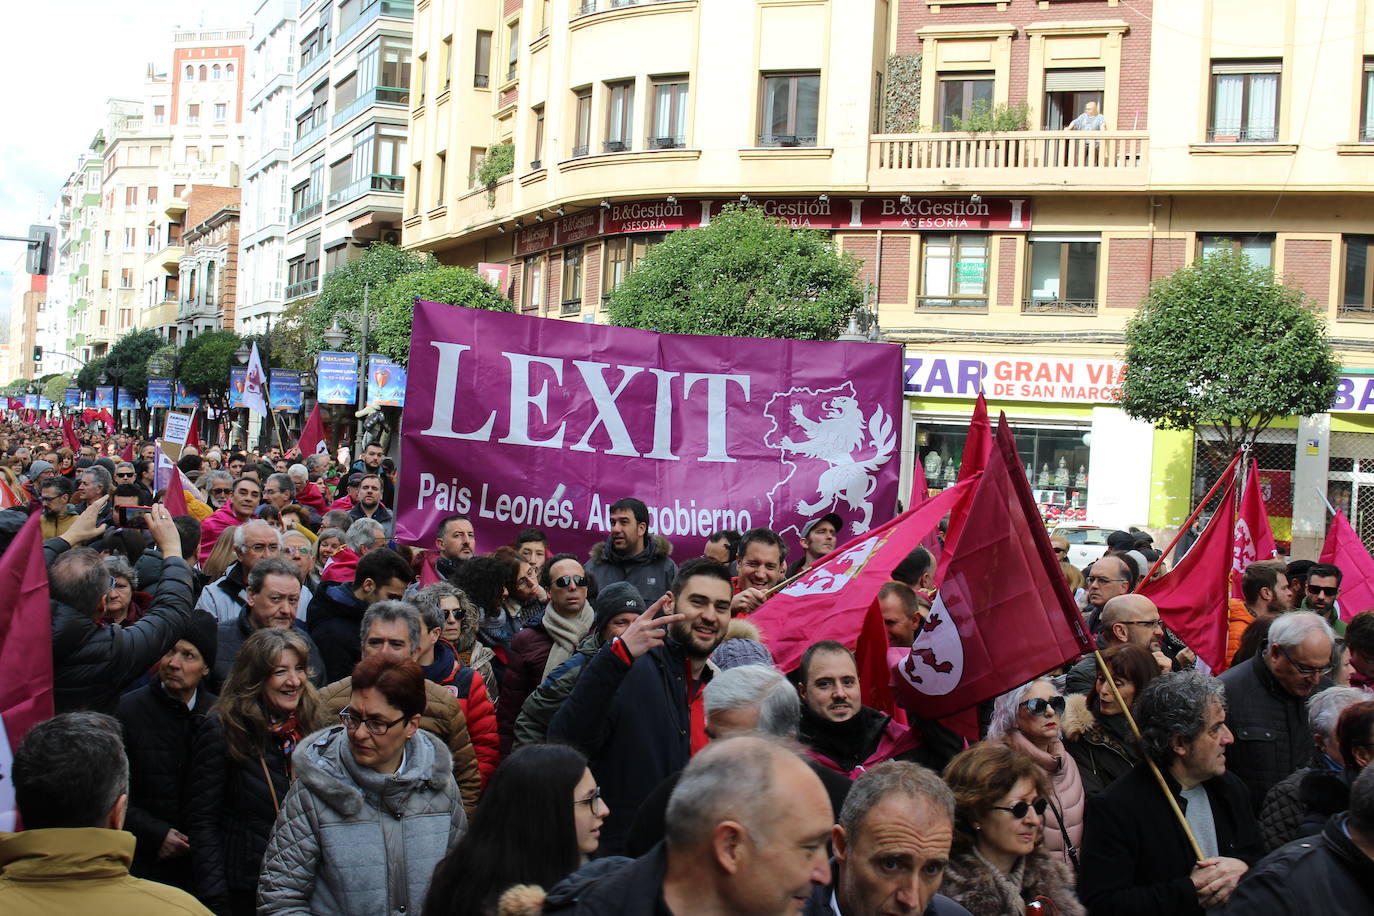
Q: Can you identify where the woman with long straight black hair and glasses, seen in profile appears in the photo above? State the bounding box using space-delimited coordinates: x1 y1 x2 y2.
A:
425 744 610 916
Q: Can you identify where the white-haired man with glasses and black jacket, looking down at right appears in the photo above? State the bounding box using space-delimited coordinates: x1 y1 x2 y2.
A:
1220 611 1336 812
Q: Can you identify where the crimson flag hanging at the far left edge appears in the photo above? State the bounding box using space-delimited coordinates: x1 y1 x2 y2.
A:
0 512 52 831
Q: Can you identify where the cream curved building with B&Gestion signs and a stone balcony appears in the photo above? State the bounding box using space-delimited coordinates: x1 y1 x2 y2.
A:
404 0 1374 552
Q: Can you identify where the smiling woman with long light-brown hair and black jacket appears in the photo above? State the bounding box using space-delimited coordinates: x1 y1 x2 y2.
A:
187 628 326 916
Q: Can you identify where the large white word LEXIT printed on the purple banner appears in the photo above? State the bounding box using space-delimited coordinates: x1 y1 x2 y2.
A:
420 341 749 461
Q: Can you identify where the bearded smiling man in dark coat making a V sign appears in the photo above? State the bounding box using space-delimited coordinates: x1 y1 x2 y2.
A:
548 559 731 856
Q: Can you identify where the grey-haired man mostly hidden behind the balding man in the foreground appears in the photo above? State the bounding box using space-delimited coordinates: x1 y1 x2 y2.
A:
625 665 852 856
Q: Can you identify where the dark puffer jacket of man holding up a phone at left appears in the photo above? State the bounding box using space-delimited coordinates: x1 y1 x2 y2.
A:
43 537 192 715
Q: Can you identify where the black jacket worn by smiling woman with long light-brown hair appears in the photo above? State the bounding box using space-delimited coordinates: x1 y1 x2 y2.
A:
187 713 291 912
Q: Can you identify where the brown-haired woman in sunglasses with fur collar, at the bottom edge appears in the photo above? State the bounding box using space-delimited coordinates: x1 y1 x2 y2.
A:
940 740 1084 916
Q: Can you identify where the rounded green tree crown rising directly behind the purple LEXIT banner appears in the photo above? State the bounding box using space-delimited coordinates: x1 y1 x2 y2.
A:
607 205 863 341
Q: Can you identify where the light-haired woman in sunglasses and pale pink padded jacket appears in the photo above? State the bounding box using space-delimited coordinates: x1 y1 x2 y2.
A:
988 677 1087 869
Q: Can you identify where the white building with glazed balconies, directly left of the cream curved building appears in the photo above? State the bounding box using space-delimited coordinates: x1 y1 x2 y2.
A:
284 0 414 302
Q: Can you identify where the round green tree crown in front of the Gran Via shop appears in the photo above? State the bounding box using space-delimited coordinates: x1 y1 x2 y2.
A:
1121 253 1340 455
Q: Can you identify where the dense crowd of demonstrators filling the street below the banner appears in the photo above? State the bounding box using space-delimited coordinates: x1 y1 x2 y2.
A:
0 417 1374 916
